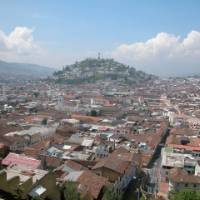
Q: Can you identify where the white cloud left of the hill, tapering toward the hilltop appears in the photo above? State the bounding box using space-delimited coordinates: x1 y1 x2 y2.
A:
0 27 88 68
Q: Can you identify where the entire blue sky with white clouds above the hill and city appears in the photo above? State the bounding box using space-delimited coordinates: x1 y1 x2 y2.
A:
0 0 200 75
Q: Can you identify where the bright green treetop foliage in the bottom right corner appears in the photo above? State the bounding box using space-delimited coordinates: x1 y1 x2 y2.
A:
169 189 200 200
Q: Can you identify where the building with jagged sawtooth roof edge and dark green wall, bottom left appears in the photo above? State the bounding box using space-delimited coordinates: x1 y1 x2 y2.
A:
0 165 60 200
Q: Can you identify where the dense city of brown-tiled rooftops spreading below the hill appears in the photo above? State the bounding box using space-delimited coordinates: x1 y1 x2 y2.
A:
0 58 200 200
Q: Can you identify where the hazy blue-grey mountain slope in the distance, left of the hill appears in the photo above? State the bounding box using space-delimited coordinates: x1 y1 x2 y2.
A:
0 60 55 81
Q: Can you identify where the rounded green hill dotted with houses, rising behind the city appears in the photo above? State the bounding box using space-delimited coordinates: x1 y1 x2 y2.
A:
53 58 155 84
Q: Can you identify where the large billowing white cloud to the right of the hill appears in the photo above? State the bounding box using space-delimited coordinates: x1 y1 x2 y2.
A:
111 31 200 75
